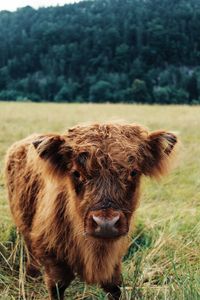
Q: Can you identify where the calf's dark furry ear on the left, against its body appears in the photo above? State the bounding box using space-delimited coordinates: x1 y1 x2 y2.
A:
33 135 73 173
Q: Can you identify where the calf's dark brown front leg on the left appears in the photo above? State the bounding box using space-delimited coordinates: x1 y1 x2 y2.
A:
45 260 74 300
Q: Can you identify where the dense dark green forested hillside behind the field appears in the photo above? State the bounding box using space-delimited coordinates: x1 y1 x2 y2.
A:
0 0 200 103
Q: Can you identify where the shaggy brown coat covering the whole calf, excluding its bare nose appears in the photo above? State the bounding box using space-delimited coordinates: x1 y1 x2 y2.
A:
6 124 177 299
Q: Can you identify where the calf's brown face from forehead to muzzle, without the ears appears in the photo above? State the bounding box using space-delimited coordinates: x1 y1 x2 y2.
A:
70 149 141 238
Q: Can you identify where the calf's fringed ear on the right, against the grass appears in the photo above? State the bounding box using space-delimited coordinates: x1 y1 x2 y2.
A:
143 131 177 178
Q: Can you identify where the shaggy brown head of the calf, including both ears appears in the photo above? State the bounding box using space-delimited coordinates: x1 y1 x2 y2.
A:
34 125 177 239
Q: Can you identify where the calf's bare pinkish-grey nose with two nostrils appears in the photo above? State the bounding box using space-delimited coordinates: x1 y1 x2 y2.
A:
92 215 120 238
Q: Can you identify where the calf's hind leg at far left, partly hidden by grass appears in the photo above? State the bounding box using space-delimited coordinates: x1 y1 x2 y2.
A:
24 237 41 277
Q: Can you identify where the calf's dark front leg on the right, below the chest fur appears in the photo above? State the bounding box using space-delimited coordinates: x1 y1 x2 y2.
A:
101 266 122 300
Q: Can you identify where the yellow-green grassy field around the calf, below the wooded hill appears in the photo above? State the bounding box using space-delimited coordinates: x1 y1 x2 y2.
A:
0 102 200 300
